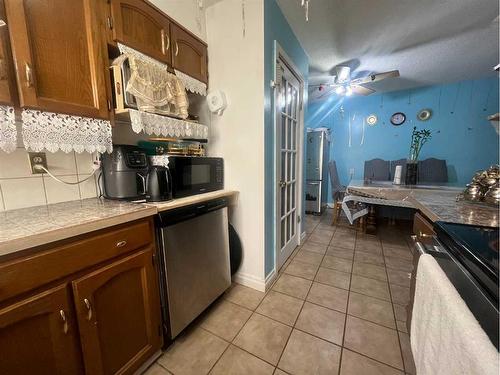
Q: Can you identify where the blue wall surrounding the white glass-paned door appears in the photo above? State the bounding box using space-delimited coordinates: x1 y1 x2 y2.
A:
264 0 309 276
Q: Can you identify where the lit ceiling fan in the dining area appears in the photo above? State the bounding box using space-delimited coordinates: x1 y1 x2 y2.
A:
313 66 399 98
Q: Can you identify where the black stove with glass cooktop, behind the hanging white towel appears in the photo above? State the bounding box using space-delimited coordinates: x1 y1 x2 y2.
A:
414 221 500 350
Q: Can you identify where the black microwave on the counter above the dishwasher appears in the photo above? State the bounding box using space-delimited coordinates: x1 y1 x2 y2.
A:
168 155 224 198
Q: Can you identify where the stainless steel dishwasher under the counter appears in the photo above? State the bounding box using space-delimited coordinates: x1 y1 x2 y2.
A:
157 198 231 342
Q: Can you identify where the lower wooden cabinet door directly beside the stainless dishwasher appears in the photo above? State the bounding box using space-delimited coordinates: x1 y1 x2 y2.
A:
73 249 161 374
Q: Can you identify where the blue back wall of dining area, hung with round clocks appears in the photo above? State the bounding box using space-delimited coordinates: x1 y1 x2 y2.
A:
305 78 499 201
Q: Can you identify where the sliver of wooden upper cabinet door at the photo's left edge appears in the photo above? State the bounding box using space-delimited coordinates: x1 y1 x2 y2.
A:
0 0 17 105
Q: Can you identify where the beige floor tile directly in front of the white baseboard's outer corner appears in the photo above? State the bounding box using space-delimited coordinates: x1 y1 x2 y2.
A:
255 290 304 326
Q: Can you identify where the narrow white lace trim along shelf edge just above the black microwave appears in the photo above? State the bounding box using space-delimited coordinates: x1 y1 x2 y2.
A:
129 109 208 139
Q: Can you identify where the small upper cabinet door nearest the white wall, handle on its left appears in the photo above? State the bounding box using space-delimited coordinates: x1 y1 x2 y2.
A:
170 24 208 83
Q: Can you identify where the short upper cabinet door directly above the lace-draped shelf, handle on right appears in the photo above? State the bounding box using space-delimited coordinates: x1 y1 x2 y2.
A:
111 0 171 64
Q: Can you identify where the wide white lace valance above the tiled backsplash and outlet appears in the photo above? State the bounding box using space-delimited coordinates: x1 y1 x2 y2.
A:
22 109 113 153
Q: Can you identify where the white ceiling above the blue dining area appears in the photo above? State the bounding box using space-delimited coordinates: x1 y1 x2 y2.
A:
277 0 499 99
